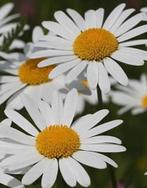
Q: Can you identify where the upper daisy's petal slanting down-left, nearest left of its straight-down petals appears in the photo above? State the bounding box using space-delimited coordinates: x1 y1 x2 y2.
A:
65 61 87 83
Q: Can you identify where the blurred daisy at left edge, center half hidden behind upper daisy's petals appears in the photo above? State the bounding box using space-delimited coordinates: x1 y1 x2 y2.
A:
0 27 63 109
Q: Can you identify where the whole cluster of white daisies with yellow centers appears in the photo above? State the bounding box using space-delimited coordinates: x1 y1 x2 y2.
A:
0 3 147 188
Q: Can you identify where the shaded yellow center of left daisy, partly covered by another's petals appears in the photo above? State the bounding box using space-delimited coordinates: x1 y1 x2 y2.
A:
18 58 55 85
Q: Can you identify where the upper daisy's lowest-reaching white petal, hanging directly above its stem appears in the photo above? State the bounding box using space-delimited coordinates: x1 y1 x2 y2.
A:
98 63 110 93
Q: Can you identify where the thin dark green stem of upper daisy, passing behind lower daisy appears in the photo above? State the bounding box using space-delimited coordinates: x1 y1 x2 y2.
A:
97 87 117 188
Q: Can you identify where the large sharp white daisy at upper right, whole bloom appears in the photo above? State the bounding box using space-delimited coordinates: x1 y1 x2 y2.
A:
31 4 147 93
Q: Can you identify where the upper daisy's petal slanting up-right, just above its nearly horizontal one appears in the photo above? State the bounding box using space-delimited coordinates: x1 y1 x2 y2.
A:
118 25 147 42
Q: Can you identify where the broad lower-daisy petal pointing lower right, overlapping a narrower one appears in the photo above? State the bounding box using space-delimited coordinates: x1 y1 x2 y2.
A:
72 151 107 169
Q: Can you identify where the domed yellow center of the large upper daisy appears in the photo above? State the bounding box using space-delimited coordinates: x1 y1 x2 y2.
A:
73 28 118 61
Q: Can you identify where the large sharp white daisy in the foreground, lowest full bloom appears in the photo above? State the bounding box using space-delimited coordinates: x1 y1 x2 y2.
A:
0 89 126 188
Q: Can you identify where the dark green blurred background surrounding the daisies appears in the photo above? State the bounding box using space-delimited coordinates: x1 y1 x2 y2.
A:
0 0 147 188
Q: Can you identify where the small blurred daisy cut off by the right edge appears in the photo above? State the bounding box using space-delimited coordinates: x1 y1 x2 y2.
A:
110 74 147 115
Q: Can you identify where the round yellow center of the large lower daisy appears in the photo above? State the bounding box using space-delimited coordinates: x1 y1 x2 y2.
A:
36 125 80 159
